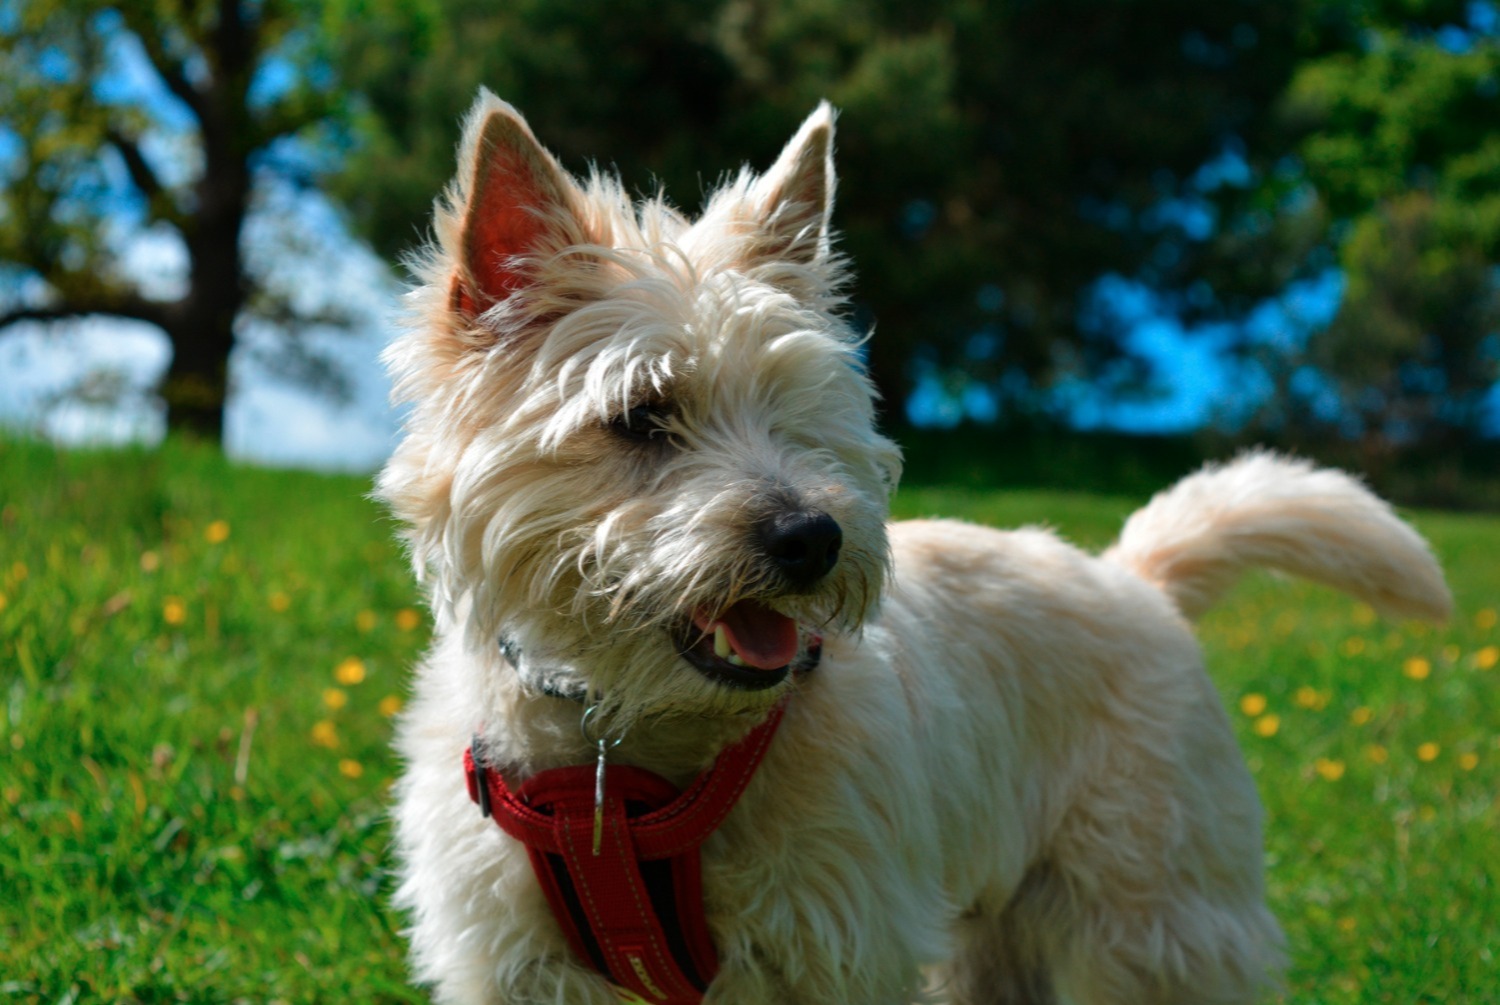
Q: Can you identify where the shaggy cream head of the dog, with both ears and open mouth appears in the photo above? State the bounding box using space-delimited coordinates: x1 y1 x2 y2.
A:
380 92 900 726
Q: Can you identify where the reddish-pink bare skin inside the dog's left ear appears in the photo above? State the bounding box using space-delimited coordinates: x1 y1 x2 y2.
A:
453 139 558 314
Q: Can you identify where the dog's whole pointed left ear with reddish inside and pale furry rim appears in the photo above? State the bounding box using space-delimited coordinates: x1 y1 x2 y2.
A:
452 89 581 317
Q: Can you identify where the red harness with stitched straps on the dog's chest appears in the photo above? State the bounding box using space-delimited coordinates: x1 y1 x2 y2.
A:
464 705 783 1005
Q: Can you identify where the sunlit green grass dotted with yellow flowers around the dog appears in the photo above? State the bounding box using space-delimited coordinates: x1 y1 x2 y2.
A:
0 441 1500 1005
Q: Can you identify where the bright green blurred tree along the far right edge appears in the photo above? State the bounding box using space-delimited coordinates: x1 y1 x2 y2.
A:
1283 2 1500 446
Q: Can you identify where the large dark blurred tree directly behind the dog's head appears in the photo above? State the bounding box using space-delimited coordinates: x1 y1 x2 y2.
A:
328 0 1340 426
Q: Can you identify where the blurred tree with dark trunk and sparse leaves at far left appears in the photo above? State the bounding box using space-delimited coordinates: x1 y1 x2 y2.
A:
0 0 360 440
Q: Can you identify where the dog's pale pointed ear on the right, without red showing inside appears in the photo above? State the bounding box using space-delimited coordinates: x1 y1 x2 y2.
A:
752 102 834 264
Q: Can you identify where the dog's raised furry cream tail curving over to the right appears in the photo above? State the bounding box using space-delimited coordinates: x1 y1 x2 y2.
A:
1104 452 1454 621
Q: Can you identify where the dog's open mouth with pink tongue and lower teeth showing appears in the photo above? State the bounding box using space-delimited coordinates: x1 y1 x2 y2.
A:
681 600 803 690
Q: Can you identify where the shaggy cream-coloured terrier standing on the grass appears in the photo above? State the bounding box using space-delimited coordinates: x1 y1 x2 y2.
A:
377 92 1451 1005
